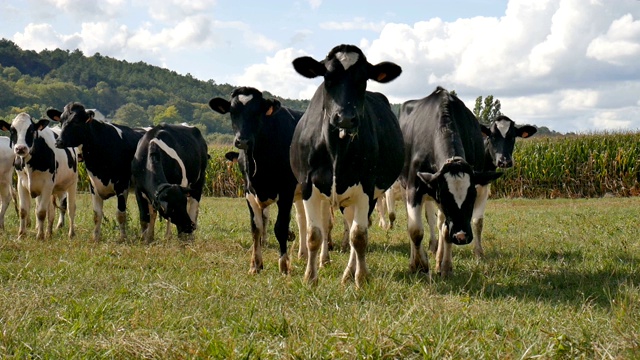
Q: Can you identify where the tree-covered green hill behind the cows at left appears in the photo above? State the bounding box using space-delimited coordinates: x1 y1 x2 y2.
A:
0 39 308 141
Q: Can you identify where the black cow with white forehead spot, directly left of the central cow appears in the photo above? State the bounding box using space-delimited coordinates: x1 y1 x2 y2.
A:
209 87 304 274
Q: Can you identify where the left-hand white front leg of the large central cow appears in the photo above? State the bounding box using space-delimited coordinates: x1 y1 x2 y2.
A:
303 187 328 285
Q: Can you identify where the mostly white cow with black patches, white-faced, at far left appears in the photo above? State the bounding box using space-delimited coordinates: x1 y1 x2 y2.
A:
0 113 78 240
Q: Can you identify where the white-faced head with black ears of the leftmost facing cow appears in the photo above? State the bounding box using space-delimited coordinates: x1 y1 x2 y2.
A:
0 113 49 158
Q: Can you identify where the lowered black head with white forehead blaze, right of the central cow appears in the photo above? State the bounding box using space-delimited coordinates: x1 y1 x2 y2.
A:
418 157 502 245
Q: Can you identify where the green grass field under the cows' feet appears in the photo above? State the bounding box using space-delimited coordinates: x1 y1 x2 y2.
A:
0 195 640 359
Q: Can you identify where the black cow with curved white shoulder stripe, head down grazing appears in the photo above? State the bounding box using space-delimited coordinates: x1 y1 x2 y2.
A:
131 124 209 243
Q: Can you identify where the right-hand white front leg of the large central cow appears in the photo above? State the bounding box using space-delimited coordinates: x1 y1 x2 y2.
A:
342 193 369 287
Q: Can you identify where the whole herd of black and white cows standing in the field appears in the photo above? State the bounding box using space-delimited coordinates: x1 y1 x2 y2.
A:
0 45 536 286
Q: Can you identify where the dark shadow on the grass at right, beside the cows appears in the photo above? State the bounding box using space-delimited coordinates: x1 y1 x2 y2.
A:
394 245 640 308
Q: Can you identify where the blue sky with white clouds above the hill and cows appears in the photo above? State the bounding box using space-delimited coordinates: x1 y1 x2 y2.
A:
0 0 640 133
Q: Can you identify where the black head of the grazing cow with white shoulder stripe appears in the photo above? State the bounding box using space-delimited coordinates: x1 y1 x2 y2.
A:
153 183 196 234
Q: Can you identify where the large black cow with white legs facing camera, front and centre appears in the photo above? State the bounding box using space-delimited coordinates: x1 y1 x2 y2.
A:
291 45 404 287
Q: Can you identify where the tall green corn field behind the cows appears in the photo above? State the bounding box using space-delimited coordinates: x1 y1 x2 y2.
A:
78 132 640 198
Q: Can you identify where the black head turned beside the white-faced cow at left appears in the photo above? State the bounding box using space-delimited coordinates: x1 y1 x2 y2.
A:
47 102 95 149
